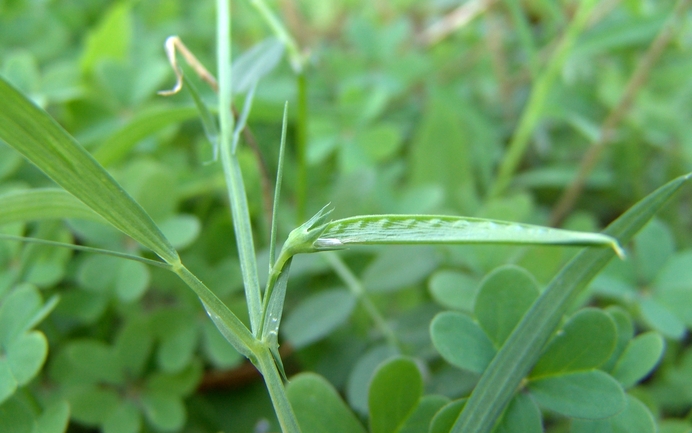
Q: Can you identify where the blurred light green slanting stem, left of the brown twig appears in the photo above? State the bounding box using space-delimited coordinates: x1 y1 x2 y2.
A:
489 0 597 197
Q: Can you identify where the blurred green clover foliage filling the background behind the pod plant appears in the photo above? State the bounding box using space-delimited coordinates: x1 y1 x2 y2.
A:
0 0 692 433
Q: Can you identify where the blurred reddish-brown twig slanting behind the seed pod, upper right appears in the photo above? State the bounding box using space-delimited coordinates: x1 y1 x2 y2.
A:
550 0 690 227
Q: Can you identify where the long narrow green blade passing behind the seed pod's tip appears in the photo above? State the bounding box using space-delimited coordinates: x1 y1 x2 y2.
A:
452 175 692 433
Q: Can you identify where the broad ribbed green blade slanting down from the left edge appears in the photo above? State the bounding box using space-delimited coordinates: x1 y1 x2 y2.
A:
0 77 180 263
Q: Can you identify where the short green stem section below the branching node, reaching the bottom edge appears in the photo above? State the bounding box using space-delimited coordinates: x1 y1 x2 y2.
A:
257 345 298 433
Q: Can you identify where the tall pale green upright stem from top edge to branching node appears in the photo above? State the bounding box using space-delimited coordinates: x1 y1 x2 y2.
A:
216 0 261 334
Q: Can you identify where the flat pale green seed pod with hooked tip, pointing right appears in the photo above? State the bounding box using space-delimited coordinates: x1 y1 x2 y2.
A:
315 215 622 255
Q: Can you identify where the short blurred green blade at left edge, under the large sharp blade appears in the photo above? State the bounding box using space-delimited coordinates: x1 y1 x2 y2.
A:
0 188 106 225
